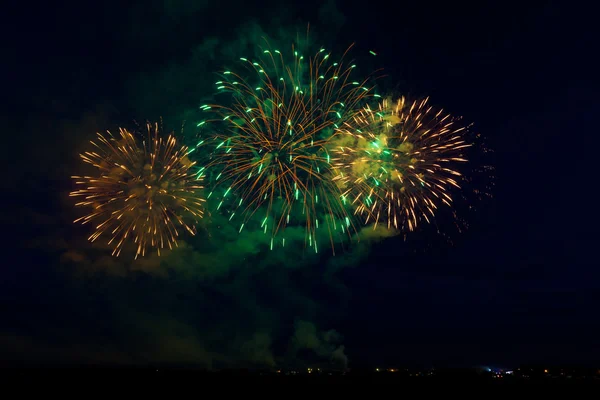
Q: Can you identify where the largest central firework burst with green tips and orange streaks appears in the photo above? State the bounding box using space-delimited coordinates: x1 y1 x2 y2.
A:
198 41 377 252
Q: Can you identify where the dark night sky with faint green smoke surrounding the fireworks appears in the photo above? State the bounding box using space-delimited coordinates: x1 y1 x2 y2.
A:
0 0 600 368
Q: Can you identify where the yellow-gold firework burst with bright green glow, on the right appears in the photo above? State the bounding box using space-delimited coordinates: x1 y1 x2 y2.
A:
334 97 472 231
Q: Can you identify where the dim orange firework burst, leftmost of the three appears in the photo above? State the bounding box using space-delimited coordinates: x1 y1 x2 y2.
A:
71 124 204 259
